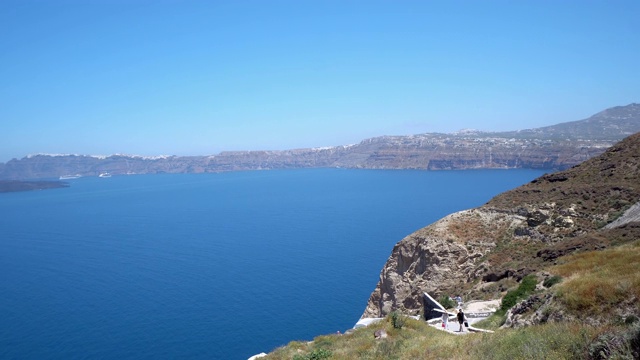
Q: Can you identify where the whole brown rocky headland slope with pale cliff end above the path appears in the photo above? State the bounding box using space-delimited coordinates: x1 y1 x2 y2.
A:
363 133 640 317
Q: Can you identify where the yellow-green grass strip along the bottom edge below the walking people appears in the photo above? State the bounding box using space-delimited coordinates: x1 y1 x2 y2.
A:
265 320 596 360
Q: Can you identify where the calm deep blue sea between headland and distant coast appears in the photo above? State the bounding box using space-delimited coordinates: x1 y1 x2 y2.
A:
0 169 543 359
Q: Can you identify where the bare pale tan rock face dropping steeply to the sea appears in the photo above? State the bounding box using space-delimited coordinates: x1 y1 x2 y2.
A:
362 209 526 317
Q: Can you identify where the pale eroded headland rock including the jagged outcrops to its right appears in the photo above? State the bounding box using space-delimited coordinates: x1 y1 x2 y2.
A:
362 202 596 317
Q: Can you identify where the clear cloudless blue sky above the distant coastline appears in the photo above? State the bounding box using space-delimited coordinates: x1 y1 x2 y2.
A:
0 0 640 162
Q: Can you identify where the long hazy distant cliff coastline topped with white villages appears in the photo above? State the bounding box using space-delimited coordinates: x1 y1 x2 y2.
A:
0 104 640 180
